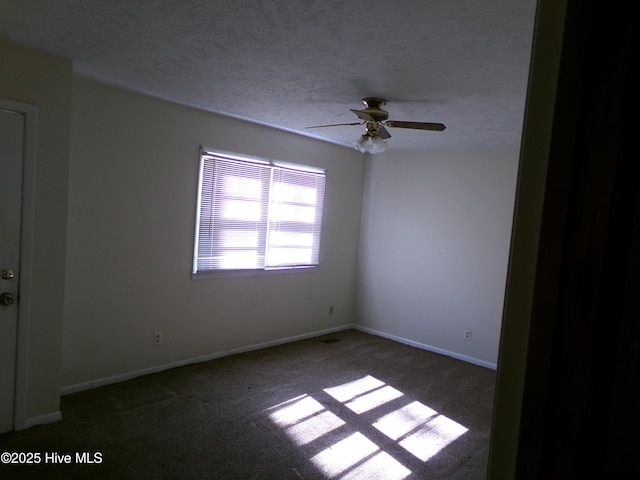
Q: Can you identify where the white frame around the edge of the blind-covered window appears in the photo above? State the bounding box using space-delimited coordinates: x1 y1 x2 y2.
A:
191 146 326 279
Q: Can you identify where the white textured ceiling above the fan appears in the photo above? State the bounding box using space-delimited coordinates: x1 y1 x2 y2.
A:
0 0 535 151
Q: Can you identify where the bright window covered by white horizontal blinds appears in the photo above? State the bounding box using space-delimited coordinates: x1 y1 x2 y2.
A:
193 151 325 273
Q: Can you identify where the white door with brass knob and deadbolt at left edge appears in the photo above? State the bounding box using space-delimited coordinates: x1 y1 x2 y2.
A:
0 110 25 432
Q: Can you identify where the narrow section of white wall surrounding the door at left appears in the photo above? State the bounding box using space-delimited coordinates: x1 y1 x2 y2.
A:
0 39 71 428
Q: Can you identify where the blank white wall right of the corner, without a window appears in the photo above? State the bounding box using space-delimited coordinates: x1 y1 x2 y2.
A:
357 149 519 367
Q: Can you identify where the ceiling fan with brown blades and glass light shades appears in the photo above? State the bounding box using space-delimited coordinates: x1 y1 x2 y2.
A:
307 97 446 153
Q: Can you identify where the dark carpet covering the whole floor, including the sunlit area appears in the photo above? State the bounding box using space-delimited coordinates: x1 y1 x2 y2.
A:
0 330 495 480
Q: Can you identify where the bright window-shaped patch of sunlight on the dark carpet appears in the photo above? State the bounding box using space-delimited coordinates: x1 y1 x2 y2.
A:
268 375 468 480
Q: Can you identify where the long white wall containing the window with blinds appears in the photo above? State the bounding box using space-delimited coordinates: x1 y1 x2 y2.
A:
62 78 362 391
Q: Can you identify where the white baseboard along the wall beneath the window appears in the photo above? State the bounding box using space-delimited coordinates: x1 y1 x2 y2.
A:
60 324 356 395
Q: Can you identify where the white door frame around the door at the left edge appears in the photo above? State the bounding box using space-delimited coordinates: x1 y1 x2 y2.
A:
0 98 38 430
